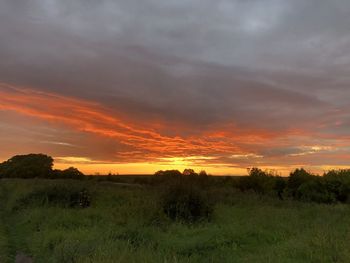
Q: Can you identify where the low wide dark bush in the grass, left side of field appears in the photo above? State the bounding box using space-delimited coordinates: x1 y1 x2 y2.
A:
17 186 91 208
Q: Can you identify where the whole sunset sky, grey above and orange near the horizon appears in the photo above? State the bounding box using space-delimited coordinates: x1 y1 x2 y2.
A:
0 0 350 175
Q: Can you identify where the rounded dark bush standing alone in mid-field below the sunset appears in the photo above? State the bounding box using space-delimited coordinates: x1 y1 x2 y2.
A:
161 180 213 222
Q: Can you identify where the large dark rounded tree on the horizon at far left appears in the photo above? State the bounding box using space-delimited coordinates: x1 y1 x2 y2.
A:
0 154 53 178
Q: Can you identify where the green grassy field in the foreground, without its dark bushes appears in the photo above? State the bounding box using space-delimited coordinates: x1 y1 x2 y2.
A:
0 179 350 263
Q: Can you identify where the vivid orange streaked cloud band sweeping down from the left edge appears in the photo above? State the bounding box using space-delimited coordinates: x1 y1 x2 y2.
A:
0 84 260 157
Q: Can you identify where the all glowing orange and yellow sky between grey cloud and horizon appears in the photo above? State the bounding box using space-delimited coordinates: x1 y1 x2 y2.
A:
0 83 348 175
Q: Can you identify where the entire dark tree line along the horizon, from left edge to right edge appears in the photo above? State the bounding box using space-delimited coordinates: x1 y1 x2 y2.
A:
0 154 350 204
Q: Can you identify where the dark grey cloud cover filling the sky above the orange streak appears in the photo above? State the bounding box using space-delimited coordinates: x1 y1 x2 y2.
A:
0 0 350 159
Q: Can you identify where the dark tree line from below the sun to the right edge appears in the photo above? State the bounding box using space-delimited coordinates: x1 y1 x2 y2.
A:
155 167 350 204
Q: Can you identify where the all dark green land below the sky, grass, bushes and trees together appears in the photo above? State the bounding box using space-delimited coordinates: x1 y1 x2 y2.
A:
0 155 350 263
